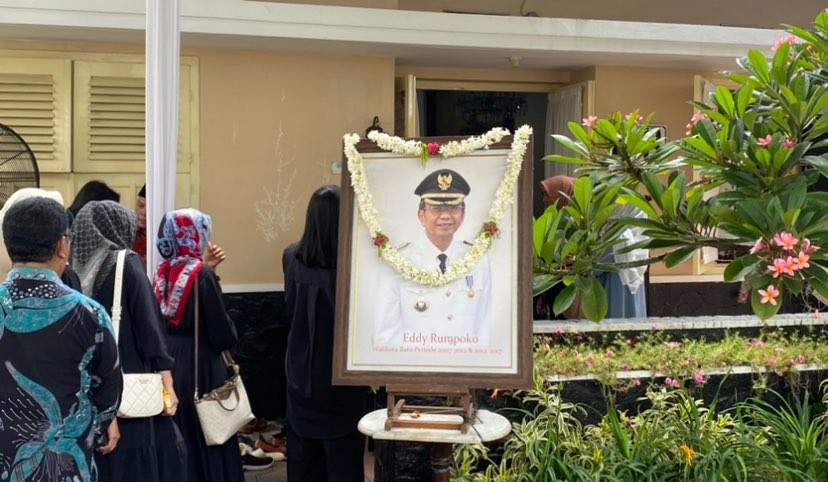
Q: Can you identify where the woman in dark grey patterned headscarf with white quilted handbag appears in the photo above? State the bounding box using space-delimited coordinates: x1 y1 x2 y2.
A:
70 201 186 482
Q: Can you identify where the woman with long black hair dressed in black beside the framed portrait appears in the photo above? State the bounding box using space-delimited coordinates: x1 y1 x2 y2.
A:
282 186 367 482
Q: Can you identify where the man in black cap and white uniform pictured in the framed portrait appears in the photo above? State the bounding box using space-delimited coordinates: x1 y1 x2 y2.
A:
373 169 492 348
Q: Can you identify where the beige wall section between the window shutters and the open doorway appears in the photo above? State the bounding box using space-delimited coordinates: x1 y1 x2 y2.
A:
197 51 394 284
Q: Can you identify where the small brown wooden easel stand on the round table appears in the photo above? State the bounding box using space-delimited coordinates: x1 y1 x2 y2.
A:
385 384 477 433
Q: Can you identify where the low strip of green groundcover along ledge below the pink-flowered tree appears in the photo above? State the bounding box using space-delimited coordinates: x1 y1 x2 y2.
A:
534 329 828 385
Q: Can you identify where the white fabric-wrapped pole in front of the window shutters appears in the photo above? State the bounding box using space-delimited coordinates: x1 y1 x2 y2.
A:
146 0 180 278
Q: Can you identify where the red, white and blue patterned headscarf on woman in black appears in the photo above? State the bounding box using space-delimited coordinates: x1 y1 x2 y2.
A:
152 209 212 326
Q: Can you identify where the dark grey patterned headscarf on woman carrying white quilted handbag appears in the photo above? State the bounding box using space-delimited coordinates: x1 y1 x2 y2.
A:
69 201 136 299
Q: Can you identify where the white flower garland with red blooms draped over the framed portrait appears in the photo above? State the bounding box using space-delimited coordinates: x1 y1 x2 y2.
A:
344 125 532 286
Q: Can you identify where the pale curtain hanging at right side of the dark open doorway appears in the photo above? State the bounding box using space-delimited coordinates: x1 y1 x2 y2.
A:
543 85 583 179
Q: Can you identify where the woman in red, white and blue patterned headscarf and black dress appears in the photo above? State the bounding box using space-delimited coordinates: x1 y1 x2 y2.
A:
153 209 244 482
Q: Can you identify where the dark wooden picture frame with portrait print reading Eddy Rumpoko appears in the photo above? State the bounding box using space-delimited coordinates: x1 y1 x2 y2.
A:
333 135 533 388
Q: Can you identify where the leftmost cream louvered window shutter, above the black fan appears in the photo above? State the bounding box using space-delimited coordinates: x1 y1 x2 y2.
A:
0 57 72 172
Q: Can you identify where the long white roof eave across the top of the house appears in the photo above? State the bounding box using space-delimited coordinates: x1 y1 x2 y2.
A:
0 0 782 71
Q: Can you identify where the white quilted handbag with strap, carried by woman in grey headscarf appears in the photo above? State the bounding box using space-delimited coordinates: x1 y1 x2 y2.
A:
112 250 164 418
